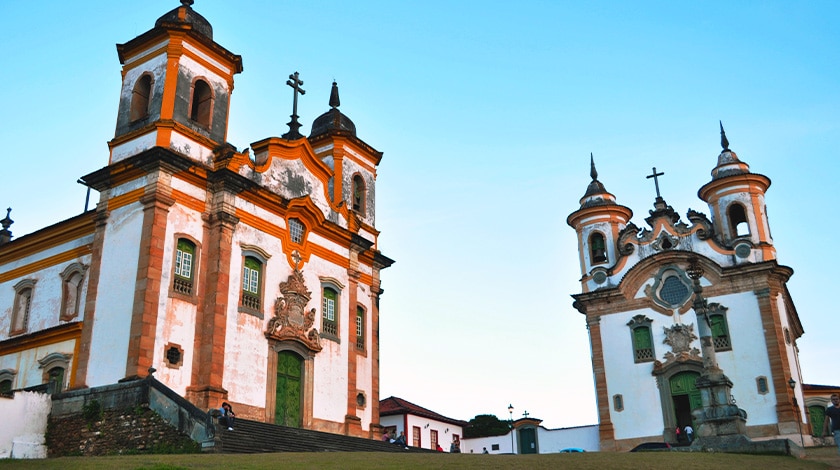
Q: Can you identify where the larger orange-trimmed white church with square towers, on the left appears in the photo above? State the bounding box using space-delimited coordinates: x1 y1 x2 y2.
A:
0 0 393 437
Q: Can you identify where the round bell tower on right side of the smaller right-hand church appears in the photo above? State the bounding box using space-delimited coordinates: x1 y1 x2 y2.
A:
697 124 776 261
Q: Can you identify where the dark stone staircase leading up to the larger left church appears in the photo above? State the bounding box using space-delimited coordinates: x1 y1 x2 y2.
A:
216 418 434 454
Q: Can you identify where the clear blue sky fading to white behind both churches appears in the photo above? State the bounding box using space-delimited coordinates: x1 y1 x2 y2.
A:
0 0 840 428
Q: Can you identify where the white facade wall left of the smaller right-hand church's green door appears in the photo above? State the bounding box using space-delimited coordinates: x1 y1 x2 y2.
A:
601 309 673 439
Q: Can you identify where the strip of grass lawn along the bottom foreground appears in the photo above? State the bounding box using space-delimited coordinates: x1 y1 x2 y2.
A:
0 447 840 470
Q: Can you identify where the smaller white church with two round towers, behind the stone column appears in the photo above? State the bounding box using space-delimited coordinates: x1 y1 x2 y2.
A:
567 125 809 451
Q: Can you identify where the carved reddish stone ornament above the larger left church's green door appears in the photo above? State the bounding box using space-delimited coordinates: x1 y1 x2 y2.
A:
265 269 322 352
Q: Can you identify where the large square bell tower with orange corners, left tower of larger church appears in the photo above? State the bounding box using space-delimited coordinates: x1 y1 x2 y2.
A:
108 0 242 164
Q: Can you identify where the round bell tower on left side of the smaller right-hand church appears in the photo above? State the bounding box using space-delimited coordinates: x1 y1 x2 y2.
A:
566 154 633 292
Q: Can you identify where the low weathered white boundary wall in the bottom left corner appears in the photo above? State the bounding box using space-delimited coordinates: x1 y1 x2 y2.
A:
0 392 52 459
